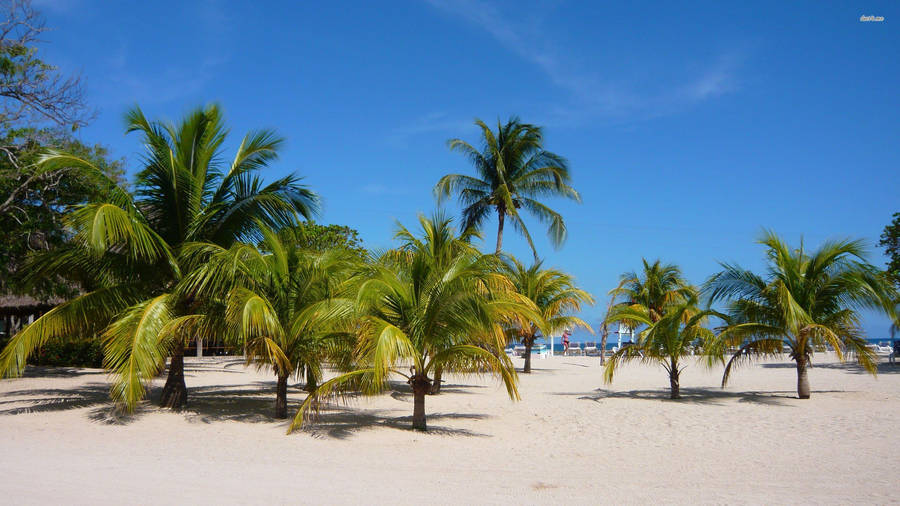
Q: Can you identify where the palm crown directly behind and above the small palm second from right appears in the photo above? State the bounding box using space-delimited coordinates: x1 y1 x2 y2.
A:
604 259 697 328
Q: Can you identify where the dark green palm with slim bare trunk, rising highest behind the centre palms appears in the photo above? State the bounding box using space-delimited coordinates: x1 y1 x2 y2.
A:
434 117 581 260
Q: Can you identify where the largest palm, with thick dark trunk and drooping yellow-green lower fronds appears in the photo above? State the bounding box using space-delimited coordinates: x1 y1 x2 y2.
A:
0 105 318 410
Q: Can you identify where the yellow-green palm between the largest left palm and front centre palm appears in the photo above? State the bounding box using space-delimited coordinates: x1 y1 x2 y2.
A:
181 228 358 418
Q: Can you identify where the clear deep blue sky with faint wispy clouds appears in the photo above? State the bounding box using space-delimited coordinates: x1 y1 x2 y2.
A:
35 0 900 338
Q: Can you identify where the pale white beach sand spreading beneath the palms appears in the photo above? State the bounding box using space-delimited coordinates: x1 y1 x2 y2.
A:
0 356 900 505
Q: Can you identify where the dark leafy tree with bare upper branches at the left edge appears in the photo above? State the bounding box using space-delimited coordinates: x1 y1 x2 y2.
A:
0 0 121 299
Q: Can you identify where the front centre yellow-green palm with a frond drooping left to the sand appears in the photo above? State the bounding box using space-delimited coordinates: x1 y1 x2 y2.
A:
290 215 529 430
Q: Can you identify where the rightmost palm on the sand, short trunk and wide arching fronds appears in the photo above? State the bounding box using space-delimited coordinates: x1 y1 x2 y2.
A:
704 231 897 399
